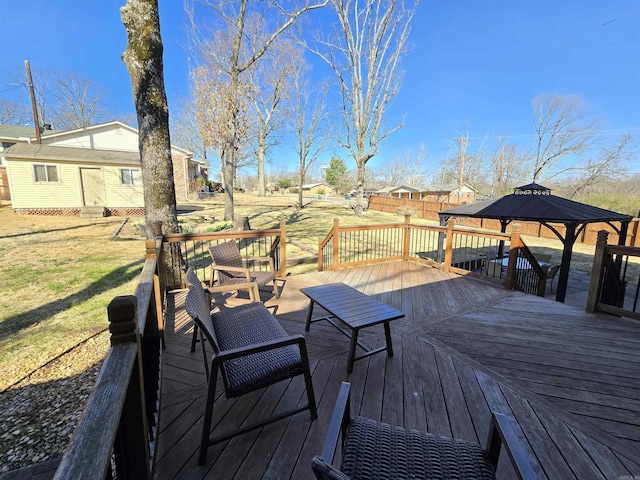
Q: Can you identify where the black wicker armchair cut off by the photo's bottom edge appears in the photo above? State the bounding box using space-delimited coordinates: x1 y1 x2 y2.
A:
311 382 538 480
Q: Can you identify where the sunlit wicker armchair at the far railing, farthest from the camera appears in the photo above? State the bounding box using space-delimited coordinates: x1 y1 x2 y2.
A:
209 241 280 298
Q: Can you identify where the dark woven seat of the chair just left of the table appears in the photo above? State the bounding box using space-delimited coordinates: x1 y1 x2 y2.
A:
211 302 303 397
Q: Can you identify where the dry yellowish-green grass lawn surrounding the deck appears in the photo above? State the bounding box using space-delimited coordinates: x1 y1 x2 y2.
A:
0 194 604 392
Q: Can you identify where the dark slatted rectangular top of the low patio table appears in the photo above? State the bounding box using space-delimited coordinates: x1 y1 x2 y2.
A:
300 283 404 328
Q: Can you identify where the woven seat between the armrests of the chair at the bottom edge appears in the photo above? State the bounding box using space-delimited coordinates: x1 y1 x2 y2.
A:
340 417 495 480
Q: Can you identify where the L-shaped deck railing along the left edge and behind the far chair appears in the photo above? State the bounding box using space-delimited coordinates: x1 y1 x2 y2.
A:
55 222 286 479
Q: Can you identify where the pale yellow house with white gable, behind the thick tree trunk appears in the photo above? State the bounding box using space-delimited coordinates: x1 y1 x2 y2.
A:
0 121 207 215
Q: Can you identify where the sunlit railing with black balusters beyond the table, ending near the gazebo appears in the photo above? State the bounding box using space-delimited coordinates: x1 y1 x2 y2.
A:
318 215 546 296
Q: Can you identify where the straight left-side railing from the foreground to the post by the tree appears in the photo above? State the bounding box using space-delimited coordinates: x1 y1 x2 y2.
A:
54 239 166 479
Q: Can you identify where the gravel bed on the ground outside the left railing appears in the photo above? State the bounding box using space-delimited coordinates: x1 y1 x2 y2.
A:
0 332 109 474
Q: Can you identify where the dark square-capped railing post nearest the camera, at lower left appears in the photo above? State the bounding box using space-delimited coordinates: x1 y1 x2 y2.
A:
107 295 151 479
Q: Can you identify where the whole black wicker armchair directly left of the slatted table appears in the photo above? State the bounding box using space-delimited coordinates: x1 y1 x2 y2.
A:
185 269 318 464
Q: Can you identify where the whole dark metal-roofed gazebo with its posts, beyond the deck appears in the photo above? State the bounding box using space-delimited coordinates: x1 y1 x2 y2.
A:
438 183 633 302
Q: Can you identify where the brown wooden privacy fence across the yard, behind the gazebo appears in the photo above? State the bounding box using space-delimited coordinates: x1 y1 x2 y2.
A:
368 196 640 247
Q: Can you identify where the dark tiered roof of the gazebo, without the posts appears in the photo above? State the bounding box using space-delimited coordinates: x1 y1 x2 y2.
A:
439 183 633 224
